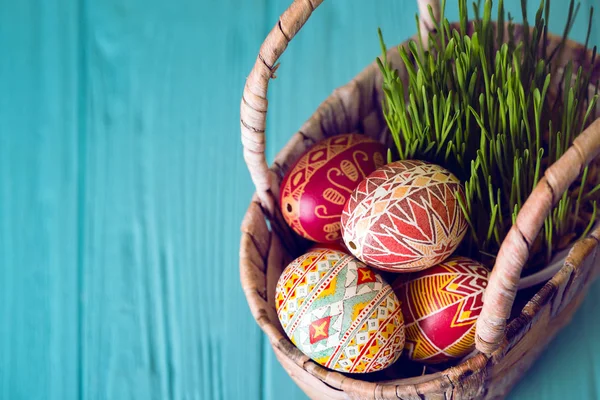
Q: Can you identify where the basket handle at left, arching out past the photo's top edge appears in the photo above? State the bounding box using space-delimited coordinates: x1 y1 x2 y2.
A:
240 0 440 213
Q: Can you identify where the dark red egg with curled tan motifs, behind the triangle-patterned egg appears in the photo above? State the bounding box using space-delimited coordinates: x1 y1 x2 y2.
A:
279 133 386 242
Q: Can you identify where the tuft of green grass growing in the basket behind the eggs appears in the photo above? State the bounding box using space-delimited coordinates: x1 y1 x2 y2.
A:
377 0 600 267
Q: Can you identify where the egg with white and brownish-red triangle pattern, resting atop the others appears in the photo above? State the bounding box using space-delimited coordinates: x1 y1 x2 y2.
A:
341 160 467 272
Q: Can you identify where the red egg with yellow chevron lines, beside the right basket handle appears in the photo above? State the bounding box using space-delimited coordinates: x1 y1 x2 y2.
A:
393 257 489 364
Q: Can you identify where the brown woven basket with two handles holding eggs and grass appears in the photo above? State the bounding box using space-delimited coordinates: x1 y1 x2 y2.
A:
240 0 600 400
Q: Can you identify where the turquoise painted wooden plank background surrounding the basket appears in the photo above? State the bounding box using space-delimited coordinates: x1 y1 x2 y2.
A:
0 0 600 400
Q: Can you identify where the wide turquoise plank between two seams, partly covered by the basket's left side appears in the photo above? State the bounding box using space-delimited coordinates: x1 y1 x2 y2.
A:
76 0 265 399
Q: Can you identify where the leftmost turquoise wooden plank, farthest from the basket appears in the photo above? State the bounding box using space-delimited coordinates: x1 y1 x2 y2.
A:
0 0 82 400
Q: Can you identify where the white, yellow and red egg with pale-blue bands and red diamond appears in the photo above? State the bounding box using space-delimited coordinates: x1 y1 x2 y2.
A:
275 249 404 373
